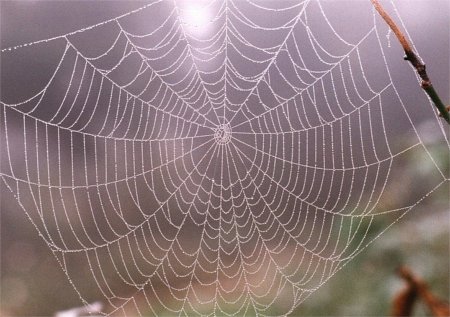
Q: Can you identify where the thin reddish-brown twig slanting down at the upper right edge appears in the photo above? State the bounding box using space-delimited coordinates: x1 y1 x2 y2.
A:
370 0 450 124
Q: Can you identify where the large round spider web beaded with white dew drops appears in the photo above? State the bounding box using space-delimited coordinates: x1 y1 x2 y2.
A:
1 0 448 316
